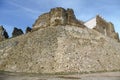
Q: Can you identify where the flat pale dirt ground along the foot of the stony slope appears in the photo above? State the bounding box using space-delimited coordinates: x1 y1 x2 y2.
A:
0 72 120 80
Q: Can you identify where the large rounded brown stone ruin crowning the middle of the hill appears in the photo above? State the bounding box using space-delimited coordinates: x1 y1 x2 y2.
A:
33 7 85 29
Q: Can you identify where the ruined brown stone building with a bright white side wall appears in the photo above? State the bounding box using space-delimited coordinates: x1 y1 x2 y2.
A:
84 15 119 41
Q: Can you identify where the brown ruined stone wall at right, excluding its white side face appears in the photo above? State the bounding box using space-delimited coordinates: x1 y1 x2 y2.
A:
94 16 119 41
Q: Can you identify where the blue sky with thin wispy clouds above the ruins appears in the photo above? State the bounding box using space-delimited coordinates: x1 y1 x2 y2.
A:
0 0 120 36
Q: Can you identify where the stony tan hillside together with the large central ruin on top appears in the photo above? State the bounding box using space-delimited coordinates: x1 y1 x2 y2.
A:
0 8 120 73
